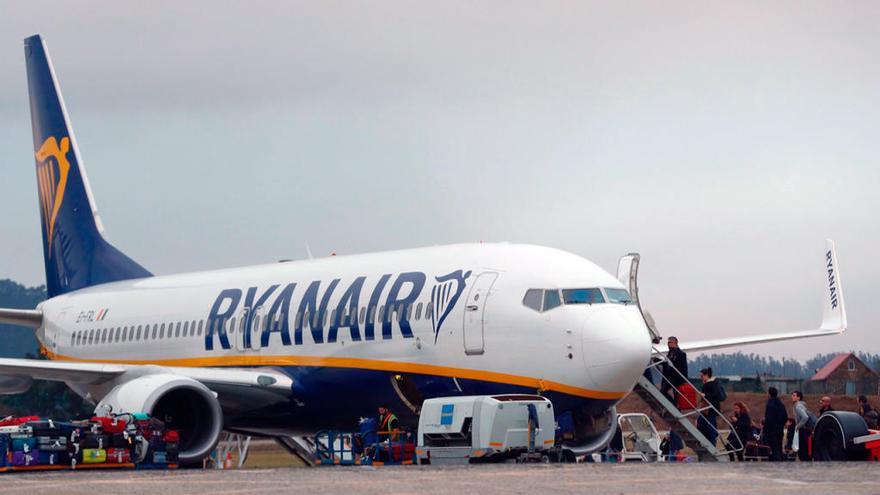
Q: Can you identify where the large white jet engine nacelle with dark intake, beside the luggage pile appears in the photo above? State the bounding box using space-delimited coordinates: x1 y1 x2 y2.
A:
95 373 223 464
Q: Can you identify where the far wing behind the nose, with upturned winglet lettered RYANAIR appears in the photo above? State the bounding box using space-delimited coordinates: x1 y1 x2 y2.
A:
654 239 846 353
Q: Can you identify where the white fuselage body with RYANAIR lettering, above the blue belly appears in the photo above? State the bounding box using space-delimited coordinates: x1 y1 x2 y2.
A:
38 244 651 426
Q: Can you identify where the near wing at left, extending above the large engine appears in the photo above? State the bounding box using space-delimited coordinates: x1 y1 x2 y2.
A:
0 359 293 393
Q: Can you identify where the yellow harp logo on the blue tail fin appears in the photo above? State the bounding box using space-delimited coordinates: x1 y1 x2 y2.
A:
36 136 70 258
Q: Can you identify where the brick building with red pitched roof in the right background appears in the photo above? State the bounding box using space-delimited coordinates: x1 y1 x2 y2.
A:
804 352 880 395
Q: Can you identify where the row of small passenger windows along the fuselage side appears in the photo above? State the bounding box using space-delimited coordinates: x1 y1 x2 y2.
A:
70 302 433 346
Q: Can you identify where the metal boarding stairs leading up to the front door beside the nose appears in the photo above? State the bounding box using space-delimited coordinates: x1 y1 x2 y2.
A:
634 349 743 462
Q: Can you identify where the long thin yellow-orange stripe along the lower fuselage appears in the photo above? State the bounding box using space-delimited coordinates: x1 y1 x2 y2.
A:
49 353 627 400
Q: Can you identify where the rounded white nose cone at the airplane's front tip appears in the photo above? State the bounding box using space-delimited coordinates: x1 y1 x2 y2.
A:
582 304 651 392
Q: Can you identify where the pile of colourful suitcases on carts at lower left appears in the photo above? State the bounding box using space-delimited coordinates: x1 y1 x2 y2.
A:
0 413 180 472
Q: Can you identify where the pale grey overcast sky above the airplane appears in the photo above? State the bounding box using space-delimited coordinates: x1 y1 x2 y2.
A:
0 0 880 358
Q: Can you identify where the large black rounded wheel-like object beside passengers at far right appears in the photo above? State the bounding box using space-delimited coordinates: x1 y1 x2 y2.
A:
813 411 868 461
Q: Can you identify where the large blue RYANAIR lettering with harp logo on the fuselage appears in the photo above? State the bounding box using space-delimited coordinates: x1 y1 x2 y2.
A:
205 270 471 351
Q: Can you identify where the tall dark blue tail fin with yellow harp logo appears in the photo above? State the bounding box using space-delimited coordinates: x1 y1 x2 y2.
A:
24 35 151 297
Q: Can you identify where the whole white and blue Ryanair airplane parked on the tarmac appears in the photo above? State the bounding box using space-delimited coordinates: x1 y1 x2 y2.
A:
0 35 846 463
